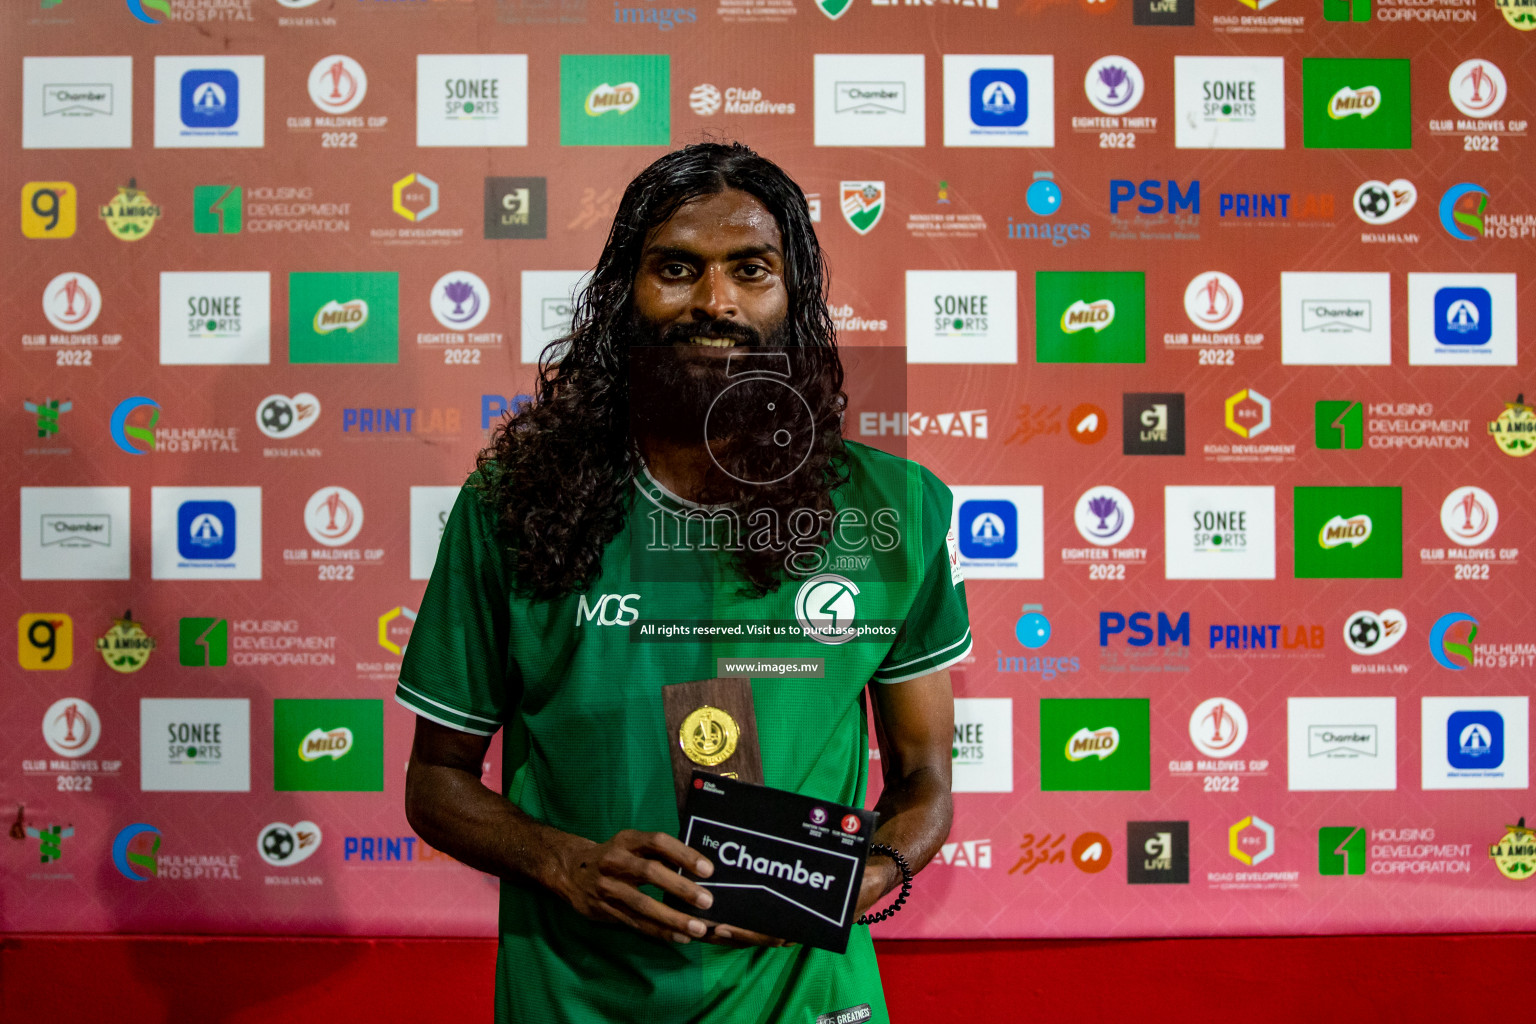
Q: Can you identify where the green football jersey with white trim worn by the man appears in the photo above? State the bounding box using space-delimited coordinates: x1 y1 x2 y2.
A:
396 444 971 1024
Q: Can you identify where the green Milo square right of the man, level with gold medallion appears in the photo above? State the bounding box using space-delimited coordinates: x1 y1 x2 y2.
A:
1040 697 1152 792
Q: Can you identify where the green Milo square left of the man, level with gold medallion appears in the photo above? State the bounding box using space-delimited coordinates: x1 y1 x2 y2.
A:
272 700 384 792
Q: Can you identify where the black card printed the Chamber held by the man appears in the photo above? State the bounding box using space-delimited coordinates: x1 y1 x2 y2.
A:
667 771 876 953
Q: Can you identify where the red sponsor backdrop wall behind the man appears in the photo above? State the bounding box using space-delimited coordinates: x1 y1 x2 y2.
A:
0 0 1536 938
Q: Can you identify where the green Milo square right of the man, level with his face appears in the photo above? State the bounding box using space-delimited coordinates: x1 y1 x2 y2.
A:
1035 270 1147 362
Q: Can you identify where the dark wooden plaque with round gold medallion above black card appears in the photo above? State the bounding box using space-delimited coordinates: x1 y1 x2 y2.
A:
662 676 763 808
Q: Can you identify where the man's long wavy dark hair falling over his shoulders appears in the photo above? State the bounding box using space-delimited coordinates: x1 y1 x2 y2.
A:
476 143 848 599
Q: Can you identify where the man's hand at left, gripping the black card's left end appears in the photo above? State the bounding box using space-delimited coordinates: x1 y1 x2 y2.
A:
559 829 714 943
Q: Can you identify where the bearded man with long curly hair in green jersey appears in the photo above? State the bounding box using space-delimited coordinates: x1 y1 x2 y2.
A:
396 143 971 1024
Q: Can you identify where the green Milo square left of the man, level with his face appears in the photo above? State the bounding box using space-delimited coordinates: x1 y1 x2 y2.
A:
289 272 399 364
